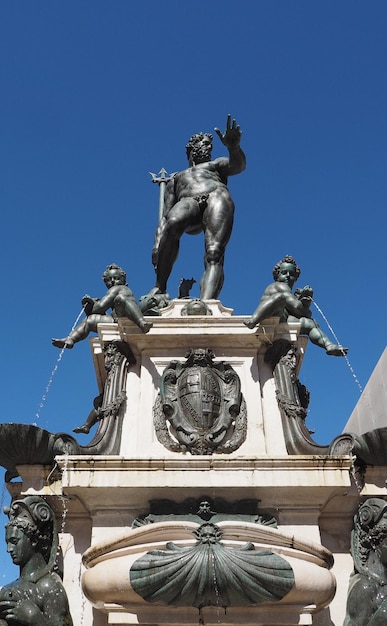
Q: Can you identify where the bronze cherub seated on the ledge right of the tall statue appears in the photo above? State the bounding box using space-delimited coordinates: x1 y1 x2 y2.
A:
245 256 348 356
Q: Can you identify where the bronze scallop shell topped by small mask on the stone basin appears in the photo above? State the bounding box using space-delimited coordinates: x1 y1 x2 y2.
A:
130 522 294 609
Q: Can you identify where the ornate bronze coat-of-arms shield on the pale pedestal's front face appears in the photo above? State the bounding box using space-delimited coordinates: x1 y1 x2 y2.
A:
154 348 247 454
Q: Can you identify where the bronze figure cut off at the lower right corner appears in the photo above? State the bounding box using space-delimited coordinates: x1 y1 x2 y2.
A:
344 498 387 626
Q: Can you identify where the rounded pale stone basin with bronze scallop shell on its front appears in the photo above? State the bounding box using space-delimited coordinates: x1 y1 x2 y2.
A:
82 521 335 624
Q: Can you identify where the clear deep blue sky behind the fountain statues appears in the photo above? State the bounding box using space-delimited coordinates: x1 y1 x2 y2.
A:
0 0 387 584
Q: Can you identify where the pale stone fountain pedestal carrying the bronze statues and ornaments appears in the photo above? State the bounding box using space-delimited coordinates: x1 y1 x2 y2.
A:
6 300 385 626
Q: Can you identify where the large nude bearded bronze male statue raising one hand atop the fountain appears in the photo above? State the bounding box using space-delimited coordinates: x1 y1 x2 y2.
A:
152 115 246 300
